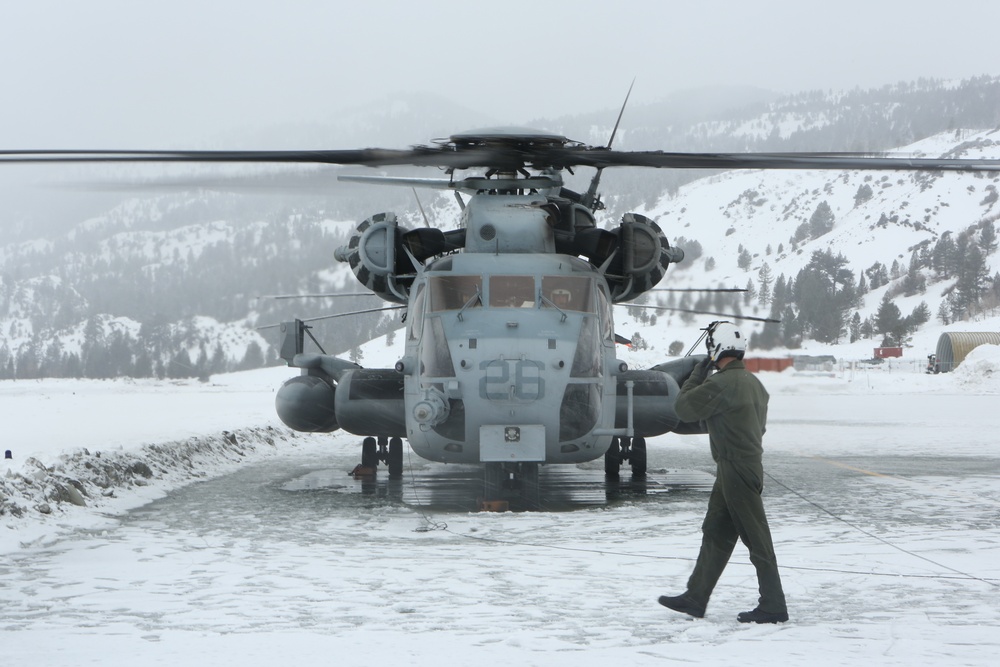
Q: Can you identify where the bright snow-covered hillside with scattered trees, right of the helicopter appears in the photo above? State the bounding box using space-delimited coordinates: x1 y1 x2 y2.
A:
618 130 1000 368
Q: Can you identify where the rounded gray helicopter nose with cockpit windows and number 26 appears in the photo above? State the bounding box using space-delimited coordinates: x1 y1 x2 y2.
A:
402 252 621 463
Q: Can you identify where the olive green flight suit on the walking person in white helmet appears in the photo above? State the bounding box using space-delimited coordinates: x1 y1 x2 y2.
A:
674 359 787 613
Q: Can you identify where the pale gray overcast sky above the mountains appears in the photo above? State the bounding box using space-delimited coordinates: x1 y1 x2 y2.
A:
0 0 1000 148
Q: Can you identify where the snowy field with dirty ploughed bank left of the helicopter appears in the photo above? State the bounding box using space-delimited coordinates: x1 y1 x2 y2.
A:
0 368 305 553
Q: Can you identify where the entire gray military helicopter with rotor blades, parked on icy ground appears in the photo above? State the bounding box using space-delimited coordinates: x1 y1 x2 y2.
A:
0 116 1000 503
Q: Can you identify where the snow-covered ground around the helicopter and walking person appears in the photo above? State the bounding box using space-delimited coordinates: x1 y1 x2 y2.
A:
0 344 1000 667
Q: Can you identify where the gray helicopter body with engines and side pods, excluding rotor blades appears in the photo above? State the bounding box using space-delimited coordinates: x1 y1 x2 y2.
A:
275 180 690 474
